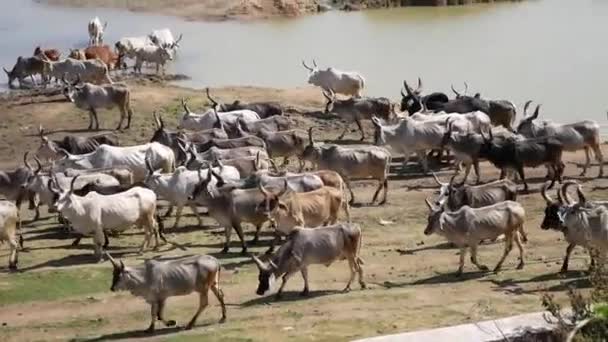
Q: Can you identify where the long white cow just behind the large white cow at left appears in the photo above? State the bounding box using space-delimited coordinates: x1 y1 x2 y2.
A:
55 142 175 182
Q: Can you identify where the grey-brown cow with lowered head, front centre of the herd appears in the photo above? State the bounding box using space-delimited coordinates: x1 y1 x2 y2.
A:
252 223 366 299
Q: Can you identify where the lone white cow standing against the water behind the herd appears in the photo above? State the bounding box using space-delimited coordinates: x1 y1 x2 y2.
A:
302 60 365 97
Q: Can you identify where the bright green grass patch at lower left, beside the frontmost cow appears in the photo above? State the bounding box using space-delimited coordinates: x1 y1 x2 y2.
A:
0 269 111 305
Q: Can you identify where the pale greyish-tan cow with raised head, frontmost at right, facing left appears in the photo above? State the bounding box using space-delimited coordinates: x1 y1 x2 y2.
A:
424 199 526 276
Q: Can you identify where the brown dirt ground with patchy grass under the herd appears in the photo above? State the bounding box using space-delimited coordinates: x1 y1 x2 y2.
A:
0 73 608 341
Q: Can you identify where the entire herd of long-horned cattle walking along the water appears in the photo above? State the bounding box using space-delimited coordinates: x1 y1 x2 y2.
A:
0 18 608 330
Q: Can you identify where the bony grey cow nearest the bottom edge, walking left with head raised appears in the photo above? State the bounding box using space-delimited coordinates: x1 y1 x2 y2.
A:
106 253 226 332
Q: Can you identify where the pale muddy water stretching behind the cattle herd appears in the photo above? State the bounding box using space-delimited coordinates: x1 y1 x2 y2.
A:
0 0 608 132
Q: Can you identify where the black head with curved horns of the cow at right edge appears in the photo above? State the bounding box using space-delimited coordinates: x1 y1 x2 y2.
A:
540 181 586 230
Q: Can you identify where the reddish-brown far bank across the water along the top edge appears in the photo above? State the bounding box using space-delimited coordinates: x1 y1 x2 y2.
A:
34 0 522 22
